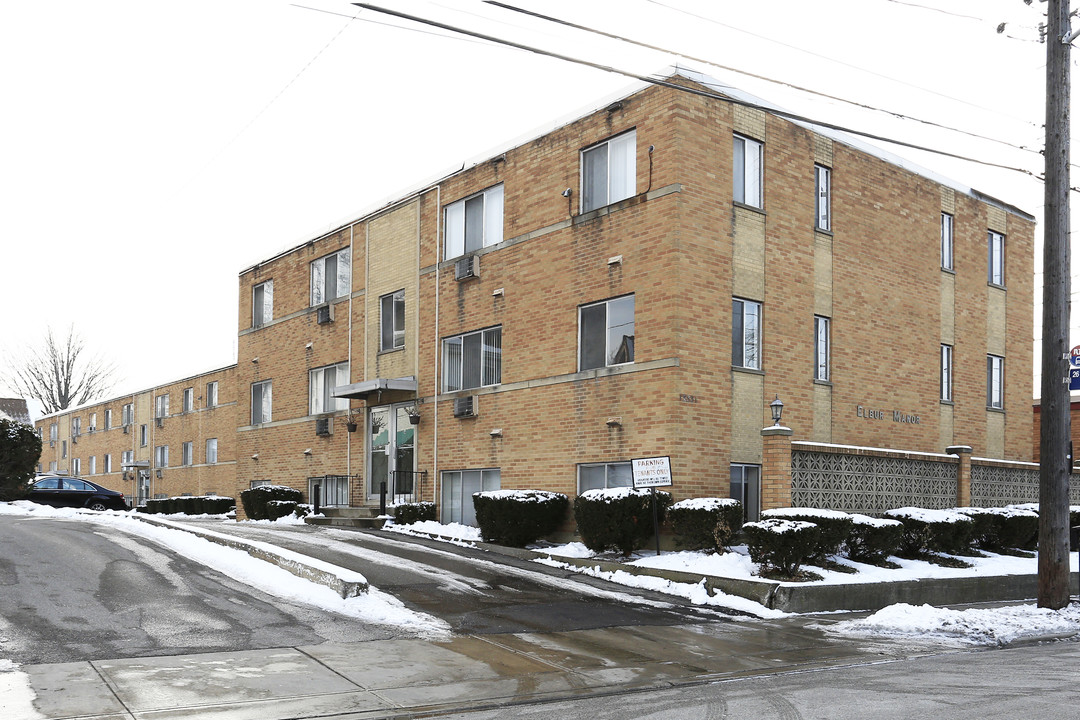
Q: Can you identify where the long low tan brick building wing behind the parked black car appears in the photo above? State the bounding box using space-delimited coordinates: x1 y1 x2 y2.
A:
36 365 237 503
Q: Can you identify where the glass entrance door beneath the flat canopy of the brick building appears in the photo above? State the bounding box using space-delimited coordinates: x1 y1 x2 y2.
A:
367 403 416 503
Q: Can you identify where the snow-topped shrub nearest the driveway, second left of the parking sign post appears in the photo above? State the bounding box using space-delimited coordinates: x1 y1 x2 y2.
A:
473 490 570 547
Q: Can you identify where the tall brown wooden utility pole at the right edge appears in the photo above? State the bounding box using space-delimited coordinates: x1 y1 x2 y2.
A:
1039 0 1074 610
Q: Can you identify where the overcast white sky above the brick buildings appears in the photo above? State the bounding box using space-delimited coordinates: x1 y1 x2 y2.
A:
0 0 1067 418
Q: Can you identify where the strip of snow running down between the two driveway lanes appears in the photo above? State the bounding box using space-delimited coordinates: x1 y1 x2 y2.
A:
0 501 449 637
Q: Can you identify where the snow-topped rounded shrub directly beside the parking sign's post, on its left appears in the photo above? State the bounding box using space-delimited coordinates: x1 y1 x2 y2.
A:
573 488 672 555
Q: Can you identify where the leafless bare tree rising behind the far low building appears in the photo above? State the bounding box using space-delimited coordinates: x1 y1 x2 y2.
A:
3 326 117 413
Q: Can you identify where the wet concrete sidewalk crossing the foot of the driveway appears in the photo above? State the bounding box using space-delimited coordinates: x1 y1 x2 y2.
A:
10 617 930 720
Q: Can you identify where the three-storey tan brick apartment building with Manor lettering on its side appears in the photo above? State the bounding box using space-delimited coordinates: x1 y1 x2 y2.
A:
39 71 1034 521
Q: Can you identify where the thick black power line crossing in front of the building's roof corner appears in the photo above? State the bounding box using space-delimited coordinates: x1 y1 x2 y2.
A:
353 2 1037 177
